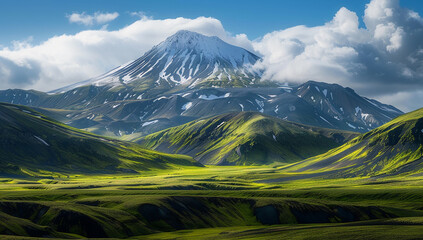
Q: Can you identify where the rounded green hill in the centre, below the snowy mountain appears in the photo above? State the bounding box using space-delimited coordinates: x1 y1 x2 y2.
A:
138 112 357 165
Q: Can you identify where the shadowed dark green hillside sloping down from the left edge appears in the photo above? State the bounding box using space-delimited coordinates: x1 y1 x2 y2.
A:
0 104 203 176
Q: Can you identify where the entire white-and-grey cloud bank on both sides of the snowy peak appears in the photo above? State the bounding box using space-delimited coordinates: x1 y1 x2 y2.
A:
0 0 423 111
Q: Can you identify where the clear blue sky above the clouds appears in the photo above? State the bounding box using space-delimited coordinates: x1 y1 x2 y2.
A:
0 0 423 46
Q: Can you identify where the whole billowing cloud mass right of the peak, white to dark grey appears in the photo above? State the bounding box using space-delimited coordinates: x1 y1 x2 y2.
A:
253 0 423 110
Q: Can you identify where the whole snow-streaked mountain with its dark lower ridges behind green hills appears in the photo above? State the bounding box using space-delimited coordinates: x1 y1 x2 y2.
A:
0 31 403 137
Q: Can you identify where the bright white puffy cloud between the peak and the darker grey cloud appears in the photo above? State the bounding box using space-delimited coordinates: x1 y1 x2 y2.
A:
254 8 363 87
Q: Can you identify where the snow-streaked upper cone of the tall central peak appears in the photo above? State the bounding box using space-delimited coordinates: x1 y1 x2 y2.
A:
56 30 261 92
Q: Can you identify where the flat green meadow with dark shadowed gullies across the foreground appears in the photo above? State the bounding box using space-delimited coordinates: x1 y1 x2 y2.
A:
0 165 423 239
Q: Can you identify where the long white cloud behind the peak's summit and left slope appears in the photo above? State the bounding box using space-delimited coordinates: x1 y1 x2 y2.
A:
0 17 252 91
